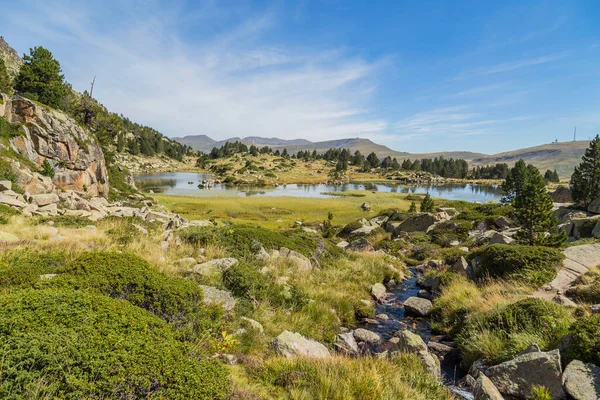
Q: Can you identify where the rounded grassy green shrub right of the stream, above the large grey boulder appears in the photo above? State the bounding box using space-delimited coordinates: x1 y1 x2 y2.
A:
457 298 572 363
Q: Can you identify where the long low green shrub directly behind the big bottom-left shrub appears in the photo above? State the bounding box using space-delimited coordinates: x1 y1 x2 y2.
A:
44 252 220 338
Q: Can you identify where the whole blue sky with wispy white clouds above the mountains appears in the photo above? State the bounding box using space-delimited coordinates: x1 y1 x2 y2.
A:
0 0 600 153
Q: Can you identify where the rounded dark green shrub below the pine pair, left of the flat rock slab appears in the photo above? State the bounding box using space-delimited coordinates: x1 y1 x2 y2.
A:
469 244 564 288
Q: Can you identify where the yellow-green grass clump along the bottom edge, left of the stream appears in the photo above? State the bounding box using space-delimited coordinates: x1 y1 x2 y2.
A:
250 354 451 400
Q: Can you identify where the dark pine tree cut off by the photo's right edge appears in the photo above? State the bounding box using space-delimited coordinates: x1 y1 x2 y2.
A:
571 135 600 206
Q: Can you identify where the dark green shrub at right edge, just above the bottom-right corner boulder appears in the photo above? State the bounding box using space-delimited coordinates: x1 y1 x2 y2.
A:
567 314 600 365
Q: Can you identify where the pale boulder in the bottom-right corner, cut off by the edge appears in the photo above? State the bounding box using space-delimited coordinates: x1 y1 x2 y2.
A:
562 360 600 400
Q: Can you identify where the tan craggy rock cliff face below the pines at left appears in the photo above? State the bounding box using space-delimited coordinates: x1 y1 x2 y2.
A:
0 94 109 196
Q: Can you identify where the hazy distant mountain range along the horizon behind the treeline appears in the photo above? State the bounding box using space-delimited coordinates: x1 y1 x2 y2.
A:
173 135 589 178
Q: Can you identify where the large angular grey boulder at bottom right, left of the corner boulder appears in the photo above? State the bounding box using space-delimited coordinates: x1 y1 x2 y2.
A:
485 350 566 400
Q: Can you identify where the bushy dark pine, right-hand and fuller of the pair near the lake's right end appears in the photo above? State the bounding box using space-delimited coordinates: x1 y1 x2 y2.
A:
512 170 566 246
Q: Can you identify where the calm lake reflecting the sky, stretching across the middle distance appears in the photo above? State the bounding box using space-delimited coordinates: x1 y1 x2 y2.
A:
135 172 501 202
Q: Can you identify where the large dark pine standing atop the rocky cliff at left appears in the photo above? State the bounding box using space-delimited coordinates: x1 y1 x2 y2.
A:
14 46 69 108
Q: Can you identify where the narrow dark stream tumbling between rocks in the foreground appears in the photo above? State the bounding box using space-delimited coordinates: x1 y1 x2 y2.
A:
357 268 473 400
